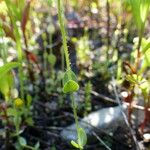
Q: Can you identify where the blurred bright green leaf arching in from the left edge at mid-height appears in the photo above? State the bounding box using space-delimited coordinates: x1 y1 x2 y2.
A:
0 62 21 79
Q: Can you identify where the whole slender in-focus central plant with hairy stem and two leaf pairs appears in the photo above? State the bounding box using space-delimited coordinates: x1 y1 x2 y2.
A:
57 0 87 149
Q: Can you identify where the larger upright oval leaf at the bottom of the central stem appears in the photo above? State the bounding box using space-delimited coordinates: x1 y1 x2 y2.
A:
78 128 87 147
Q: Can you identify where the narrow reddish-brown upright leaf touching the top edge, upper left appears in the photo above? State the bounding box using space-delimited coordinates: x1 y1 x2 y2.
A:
21 0 31 33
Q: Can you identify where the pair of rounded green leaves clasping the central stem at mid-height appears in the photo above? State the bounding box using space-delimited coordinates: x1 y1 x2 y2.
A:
63 70 79 93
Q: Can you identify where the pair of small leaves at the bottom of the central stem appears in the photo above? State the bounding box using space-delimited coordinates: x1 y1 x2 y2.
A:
71 128 87 149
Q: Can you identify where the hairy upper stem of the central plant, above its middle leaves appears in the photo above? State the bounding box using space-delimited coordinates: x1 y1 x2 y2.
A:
57 0 71 70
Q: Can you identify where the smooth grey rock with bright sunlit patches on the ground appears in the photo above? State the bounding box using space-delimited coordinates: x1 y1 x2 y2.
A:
60 106 127 141
